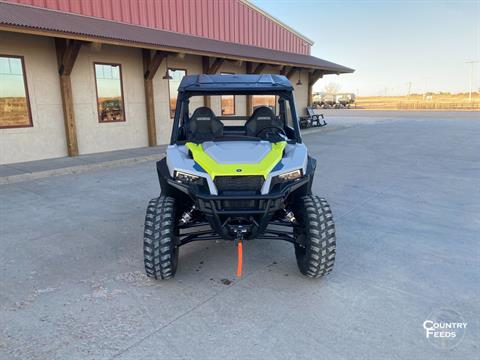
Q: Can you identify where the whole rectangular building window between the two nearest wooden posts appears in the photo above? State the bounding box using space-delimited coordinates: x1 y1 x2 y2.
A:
94 63 125 123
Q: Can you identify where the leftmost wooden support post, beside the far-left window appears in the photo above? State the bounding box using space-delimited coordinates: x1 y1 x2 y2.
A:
55 38 82 156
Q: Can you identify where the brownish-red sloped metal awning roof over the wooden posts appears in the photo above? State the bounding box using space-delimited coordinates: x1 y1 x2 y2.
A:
0 2 354 74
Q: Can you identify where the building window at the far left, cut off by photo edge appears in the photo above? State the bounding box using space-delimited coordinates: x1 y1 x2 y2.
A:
0 55 32 128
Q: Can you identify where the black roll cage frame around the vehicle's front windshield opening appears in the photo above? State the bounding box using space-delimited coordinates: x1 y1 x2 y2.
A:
170 90 302 145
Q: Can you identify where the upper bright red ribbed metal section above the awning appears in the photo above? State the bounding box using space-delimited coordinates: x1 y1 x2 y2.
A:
1 0 311 55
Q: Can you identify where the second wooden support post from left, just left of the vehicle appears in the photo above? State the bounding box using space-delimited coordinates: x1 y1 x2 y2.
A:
142 49 168 146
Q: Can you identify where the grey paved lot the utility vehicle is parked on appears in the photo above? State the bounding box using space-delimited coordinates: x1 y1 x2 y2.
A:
0 111 480 360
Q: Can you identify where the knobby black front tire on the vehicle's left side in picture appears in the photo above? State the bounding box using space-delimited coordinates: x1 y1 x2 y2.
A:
143 196 178 279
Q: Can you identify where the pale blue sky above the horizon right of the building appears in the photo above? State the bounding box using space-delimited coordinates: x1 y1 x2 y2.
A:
251 0 480 96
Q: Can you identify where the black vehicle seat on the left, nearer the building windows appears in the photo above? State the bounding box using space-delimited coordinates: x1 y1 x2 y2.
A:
186 106 223 141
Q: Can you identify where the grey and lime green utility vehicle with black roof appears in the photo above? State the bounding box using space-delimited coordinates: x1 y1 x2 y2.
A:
144 74 335 279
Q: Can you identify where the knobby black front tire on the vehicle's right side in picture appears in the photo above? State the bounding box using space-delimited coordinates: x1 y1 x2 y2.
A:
294 195 336 278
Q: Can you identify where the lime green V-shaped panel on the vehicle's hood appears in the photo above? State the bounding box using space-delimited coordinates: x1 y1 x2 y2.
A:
185 141 287 180
